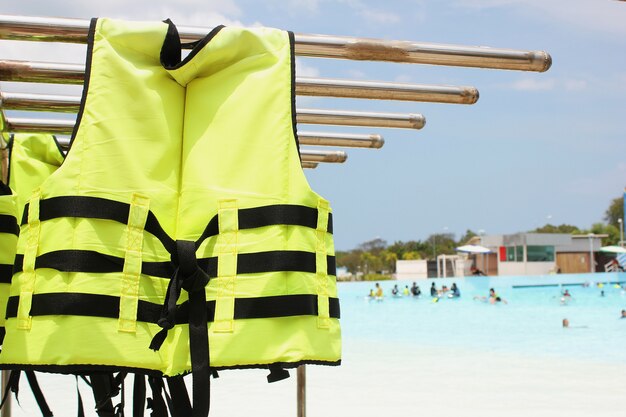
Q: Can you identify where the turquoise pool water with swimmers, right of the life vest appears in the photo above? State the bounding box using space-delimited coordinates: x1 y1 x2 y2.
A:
339 274 626 363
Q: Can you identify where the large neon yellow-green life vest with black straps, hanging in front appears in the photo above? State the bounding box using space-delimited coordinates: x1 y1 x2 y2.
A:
0 19 341 386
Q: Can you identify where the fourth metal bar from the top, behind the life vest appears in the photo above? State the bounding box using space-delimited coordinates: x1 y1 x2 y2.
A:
5 117 366 148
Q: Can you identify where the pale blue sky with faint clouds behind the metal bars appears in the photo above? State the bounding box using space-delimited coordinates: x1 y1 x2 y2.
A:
0 0 626 249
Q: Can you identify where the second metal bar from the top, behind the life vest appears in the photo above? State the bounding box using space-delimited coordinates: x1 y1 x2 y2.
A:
0 60 478 104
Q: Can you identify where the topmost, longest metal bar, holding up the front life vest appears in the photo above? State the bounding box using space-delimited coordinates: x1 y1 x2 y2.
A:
0 15 552 72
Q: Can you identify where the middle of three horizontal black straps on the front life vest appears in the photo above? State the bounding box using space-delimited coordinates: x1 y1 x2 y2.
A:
13 250 336 283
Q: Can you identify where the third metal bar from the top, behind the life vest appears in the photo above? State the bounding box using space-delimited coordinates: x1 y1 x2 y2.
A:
0 92 426 129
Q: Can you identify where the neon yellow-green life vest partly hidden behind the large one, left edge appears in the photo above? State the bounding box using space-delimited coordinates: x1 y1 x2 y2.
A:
0 134 63 343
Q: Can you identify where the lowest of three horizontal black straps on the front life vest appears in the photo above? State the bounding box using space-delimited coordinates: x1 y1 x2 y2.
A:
6 293 340 324
